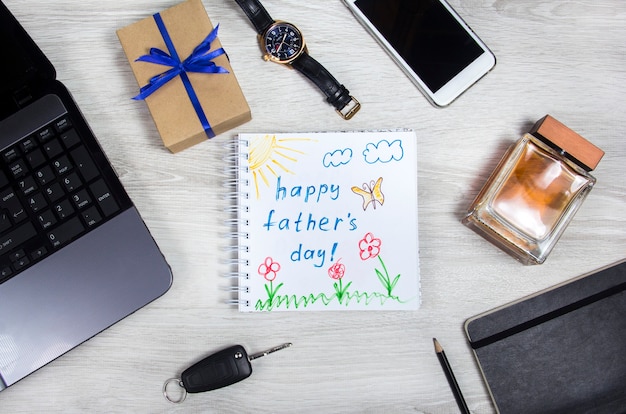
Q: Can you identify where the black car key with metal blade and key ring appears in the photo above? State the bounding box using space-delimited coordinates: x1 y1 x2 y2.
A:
163 342 292 404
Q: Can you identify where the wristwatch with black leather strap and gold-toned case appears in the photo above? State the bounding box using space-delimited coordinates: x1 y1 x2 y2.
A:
235 0 361 119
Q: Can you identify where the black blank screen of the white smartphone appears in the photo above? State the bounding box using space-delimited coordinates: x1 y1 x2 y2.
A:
354 0 485 92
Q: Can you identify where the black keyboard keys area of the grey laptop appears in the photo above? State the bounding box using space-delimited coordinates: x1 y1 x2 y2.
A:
0 114 123 283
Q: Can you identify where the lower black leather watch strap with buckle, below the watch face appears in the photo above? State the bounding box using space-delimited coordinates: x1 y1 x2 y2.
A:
291 52 360 119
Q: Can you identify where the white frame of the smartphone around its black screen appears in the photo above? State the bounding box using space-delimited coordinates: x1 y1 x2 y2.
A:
343 0 496 107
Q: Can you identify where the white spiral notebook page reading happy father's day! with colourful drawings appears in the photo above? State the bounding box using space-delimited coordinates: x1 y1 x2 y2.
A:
232 131 420 312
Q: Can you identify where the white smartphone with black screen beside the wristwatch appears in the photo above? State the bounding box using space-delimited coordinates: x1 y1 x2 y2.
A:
343 0 496 107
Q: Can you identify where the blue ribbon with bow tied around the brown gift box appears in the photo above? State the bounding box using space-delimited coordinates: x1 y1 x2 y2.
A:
133 13 229 138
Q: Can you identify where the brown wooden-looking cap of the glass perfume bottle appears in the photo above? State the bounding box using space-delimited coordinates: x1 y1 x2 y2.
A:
530 115 604 171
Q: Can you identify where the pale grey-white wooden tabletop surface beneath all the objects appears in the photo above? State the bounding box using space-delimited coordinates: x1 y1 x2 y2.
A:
0 0 626 414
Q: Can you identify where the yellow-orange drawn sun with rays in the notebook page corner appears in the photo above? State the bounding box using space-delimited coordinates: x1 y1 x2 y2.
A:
248 135 313 198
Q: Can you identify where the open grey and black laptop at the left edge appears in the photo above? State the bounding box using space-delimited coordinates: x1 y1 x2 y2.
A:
0 2 172 391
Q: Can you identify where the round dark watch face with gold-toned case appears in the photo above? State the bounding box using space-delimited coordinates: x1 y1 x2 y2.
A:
261 22 304 63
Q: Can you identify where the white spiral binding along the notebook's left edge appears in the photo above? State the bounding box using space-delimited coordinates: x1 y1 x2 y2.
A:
223 139 250 307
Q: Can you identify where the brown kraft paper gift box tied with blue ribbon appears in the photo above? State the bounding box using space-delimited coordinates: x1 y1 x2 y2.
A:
117 0 251 153
